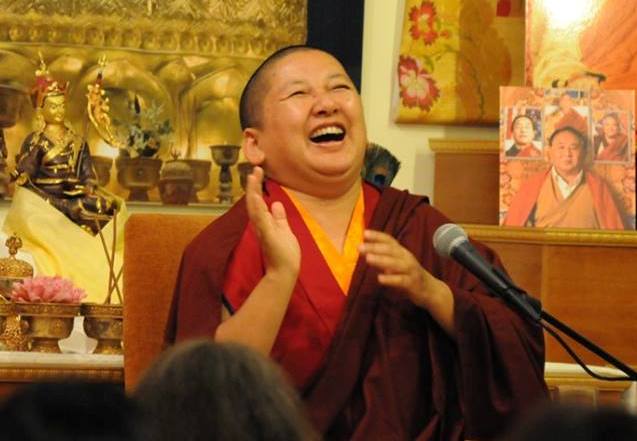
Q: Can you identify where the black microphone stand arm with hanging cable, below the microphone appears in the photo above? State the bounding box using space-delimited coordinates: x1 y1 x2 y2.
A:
490 267 637 381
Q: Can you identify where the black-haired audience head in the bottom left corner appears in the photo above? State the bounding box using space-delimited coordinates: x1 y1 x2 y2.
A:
0 381 143 441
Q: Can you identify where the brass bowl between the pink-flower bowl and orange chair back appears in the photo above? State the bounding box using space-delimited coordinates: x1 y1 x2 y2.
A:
82 303 124 354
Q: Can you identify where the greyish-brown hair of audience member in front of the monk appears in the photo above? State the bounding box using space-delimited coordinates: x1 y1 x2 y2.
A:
134 340 313 441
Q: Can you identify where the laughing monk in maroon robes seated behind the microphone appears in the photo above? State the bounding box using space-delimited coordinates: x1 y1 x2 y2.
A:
167 46 547 441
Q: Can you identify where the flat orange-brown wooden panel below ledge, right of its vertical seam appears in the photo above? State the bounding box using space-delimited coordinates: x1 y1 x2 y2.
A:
542 245 637 364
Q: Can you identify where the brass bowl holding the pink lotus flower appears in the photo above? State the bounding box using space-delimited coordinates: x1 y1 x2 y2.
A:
14 303 80 353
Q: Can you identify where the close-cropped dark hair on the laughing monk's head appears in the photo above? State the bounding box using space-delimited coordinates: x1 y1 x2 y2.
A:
239 45 322 130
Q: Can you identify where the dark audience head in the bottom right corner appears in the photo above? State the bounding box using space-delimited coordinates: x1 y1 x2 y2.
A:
502 403 637 441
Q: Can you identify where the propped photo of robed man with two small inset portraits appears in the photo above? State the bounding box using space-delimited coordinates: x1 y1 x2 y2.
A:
499 87 635 230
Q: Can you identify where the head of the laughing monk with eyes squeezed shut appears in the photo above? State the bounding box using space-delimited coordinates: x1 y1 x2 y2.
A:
239 46 367 197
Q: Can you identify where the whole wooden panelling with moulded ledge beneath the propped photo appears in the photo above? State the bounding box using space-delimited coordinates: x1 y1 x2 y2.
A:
466 225 637 365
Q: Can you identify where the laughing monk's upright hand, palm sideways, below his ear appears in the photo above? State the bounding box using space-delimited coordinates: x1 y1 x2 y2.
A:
246 167 301 279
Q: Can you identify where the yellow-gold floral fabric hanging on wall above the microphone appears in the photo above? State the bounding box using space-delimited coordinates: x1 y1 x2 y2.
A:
394 0 524 124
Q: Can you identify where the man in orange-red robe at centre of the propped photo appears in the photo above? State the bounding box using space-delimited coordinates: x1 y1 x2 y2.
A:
503 126 625 230
